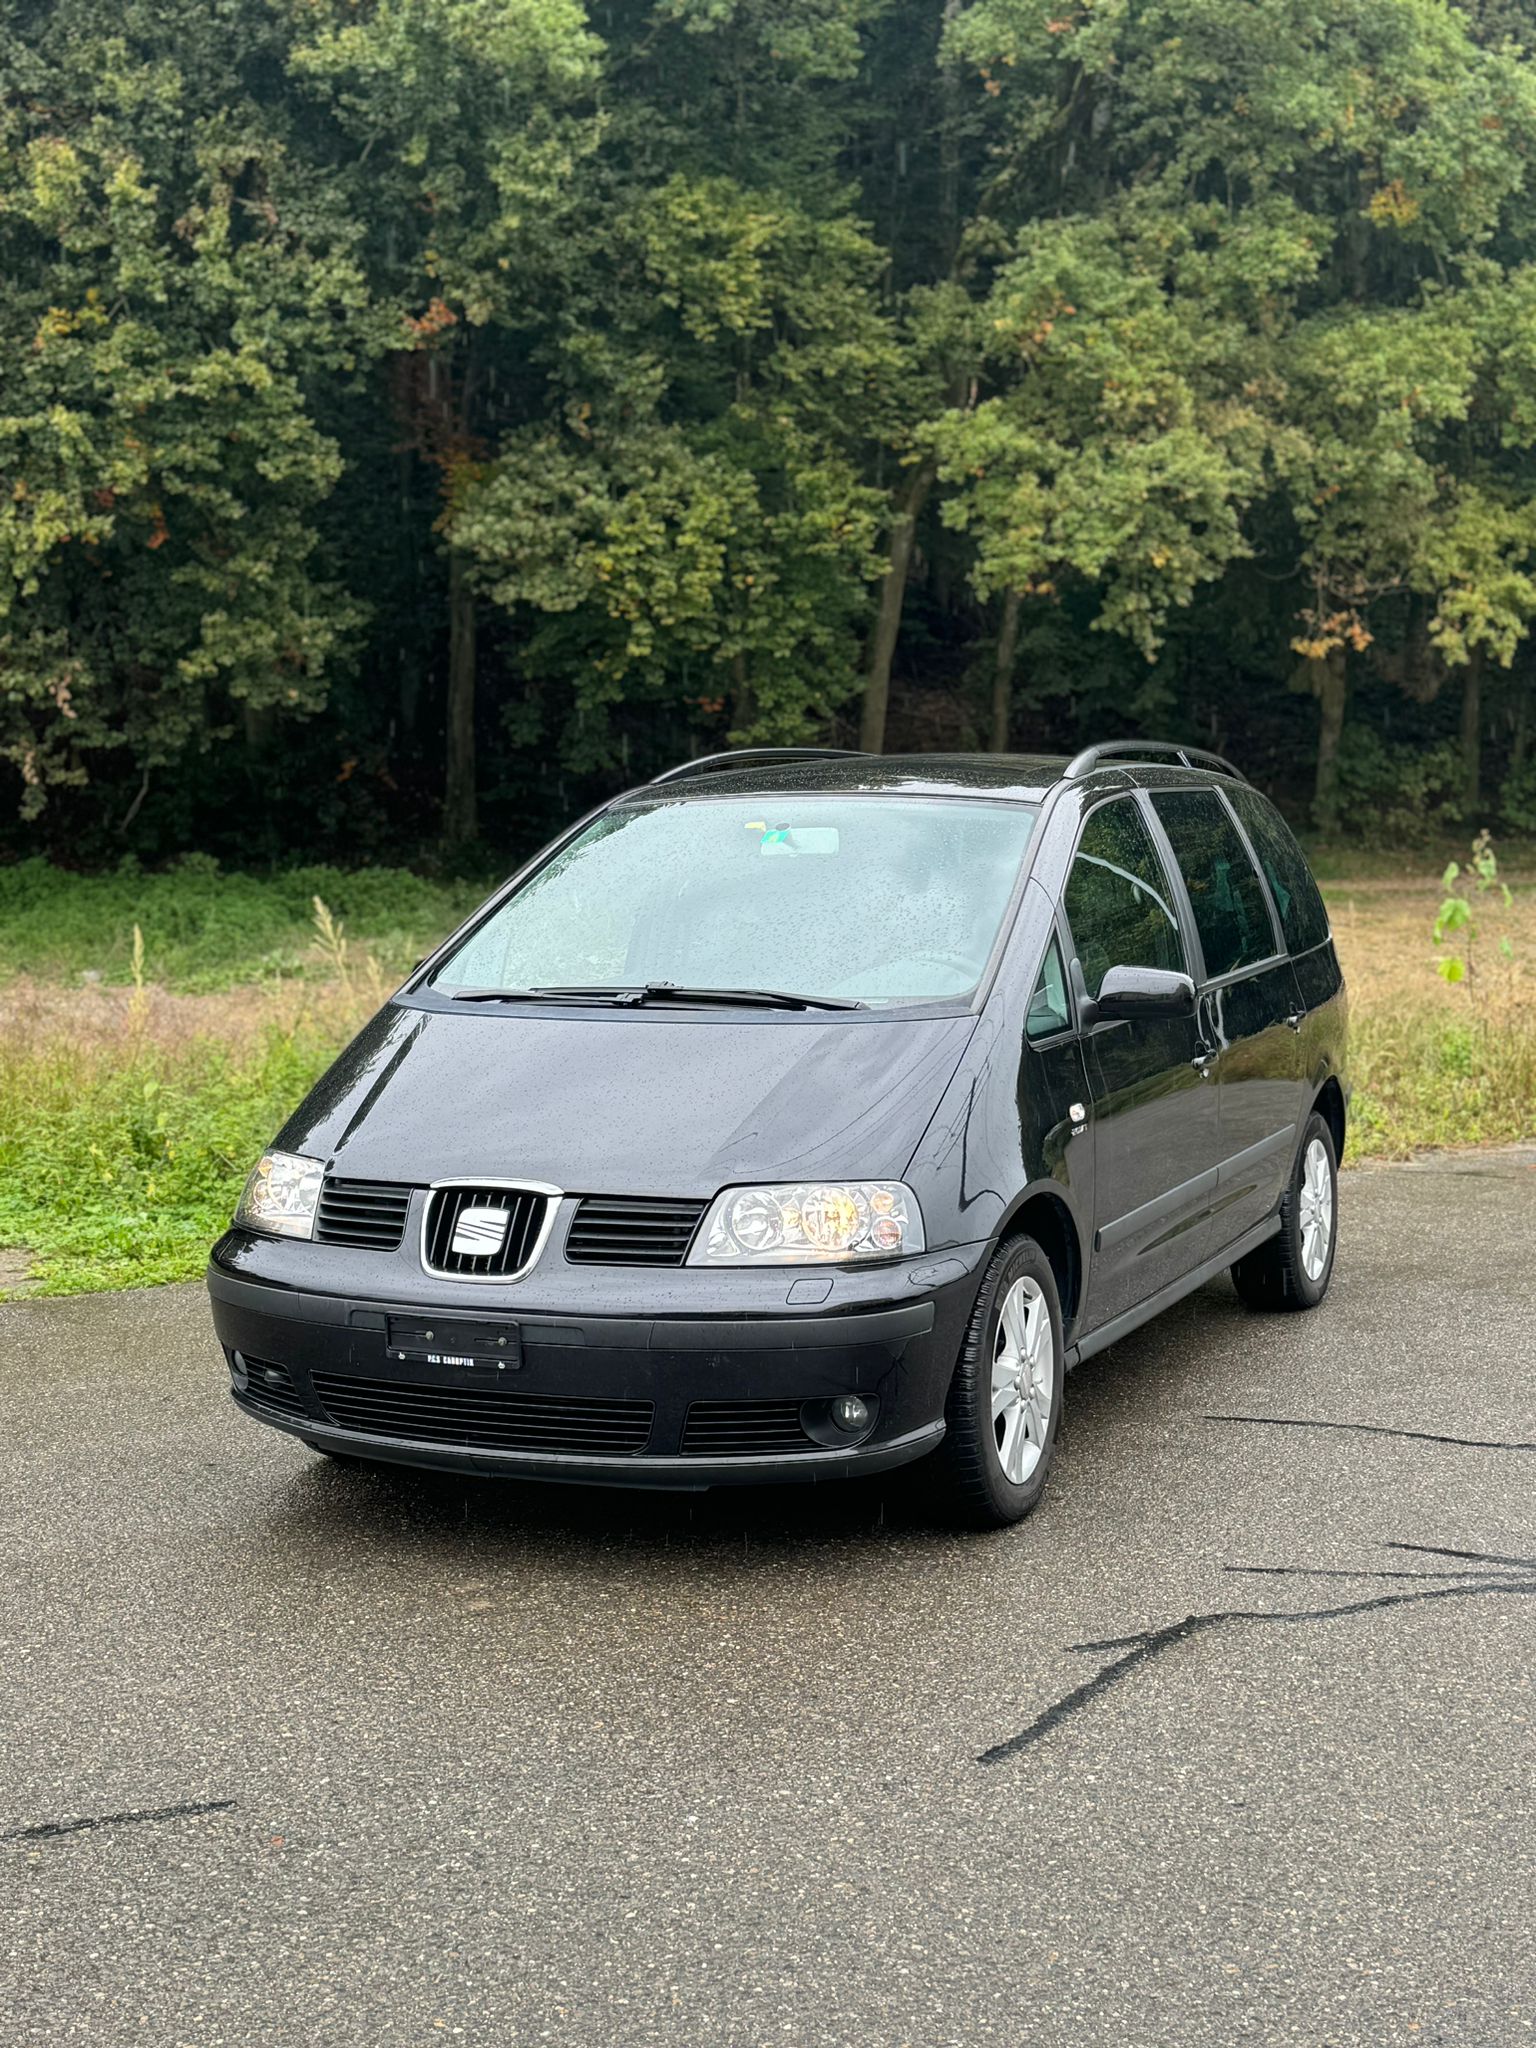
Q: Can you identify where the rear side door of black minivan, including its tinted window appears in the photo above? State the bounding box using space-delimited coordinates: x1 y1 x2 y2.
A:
1153 788 1305 1255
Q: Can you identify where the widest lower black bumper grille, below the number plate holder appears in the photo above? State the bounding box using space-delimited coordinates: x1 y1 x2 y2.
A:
313 1372 653 1458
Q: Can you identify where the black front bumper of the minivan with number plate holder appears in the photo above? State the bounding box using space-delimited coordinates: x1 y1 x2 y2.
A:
207 1239 985 1491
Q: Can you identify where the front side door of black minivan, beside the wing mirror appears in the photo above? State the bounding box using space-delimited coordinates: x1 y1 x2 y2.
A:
1065 795 1221 1331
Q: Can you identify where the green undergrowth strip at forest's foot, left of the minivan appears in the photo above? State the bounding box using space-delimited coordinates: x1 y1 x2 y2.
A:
0 854 485 991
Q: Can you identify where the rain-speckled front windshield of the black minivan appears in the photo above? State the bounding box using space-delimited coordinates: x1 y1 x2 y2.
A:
434 795 1036 1004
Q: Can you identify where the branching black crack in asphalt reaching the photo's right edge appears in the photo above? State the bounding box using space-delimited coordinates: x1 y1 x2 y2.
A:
977 1542 1536 1763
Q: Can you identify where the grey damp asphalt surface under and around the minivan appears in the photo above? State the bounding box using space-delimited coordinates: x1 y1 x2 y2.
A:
0 1151 1536 2048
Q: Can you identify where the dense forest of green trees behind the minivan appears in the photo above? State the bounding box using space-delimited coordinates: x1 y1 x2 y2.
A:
0 0 1536 862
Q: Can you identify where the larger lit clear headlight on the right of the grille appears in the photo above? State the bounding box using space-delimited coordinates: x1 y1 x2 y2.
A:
688 1180 924 1266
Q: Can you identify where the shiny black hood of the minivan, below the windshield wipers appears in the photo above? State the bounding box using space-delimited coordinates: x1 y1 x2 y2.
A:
276 1004 975 1196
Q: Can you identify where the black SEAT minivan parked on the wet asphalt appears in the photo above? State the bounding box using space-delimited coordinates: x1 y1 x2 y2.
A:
209 741 1348 1526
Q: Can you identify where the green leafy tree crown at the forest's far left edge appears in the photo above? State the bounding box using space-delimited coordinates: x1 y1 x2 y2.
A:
0 0 380 817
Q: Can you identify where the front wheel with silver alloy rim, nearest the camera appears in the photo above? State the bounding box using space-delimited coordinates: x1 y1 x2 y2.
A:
934 1237 1065 1530
